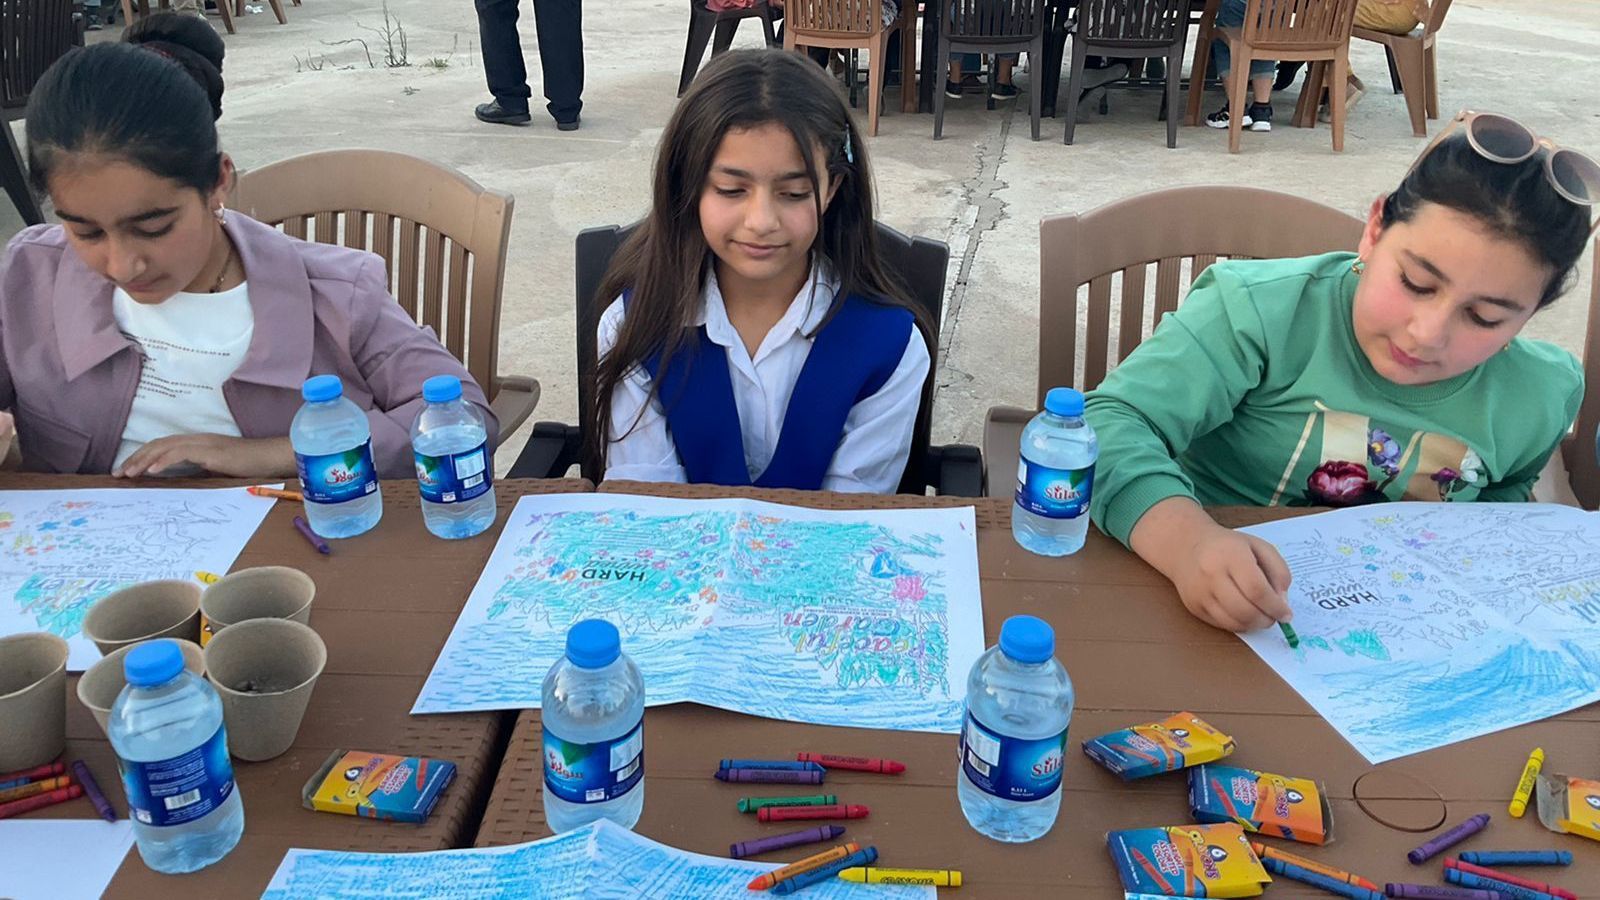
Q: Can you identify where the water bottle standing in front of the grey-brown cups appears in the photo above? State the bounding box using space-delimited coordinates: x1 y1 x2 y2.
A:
106 641 245 874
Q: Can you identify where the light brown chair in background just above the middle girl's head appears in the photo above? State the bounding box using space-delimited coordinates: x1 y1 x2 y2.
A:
784 0 917 138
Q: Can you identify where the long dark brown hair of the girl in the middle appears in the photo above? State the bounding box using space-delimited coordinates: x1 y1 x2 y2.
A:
582 50 930 479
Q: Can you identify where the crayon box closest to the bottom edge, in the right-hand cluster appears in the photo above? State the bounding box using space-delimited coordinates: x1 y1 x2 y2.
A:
1106 825 1272 897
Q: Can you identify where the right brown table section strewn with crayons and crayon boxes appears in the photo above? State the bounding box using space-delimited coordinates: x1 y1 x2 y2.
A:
477 484 1600 900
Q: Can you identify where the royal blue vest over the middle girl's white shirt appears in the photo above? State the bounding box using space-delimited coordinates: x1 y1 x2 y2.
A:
645 295 915 490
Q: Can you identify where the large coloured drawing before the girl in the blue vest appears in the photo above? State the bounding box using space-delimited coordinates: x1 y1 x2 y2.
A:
413 493 984 733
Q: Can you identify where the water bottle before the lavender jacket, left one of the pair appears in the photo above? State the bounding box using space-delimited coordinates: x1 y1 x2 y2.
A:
290 375 384 538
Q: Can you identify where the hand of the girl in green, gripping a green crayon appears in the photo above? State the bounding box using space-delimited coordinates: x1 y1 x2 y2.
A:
1171 524 1291 631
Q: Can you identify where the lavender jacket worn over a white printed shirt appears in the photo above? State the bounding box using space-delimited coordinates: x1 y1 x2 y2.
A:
0 211 499 477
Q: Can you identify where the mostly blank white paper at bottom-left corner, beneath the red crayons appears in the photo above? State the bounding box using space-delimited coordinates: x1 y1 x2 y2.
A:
0 816 133 900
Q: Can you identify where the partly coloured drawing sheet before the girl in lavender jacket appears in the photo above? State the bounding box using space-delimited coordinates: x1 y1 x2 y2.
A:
0 487 274 671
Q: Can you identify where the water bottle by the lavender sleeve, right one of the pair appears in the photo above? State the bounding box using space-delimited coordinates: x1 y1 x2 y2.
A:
411 375 494 538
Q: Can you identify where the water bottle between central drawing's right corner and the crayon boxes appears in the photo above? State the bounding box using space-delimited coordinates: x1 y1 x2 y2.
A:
955 615 1074 842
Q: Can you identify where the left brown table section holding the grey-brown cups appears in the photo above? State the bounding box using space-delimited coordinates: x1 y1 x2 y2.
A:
0 474 590 898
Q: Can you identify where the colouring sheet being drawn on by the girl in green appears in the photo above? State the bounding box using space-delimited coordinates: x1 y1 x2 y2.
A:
1240 503 1600 762
